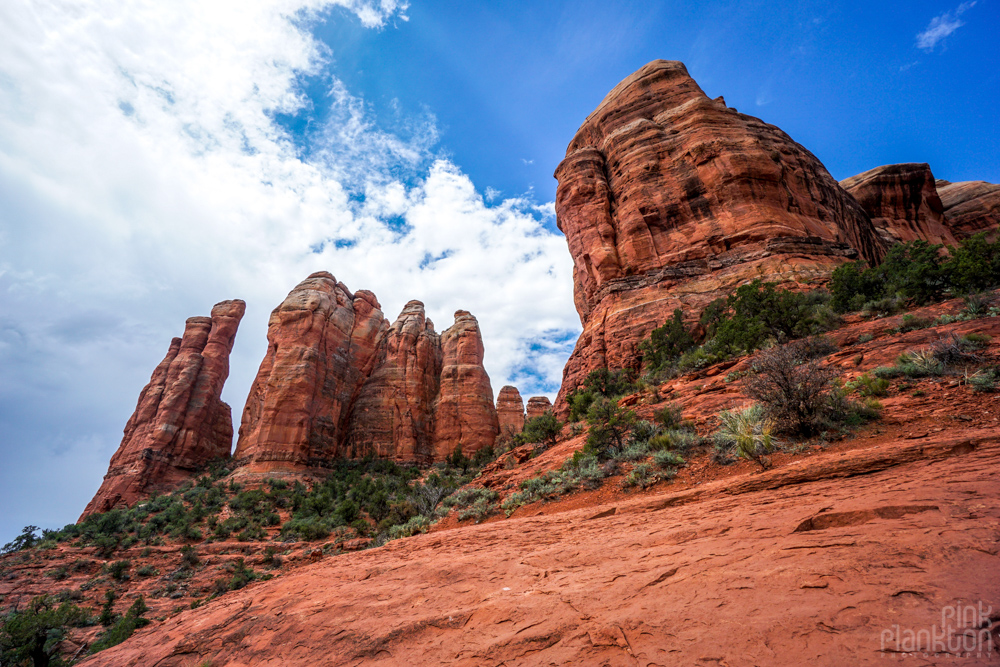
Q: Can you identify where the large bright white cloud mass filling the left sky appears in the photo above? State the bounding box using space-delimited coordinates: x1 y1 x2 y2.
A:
0 0 579 542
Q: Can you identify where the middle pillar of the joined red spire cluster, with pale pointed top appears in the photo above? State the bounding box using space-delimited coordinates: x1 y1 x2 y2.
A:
345 301 442 461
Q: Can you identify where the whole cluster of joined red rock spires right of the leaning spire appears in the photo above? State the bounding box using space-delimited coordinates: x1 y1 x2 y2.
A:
234 272 499 474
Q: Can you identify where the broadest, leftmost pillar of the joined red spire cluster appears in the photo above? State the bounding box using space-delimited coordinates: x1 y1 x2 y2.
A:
234 271 389 473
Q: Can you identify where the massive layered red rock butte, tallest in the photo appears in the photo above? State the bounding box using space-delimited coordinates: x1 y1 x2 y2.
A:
555 60 885 412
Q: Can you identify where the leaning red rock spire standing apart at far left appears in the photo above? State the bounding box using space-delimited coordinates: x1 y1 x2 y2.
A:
80 300 246 519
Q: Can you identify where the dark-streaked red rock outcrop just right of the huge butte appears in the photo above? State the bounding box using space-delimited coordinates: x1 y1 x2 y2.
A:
840 164 958 246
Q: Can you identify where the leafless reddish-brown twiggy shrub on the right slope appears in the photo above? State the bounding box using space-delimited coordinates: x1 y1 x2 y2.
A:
743 342 837 435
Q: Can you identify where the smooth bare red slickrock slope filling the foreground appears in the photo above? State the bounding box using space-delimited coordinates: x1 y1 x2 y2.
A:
83 429 1000 667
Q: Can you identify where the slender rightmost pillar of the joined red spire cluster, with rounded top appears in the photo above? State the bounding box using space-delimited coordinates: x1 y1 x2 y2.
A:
433 310 500 461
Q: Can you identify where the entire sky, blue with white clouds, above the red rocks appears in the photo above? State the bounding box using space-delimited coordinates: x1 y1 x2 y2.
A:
0 0 1000 543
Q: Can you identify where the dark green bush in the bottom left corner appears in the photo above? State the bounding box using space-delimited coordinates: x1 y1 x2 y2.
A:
0 595 88 667
